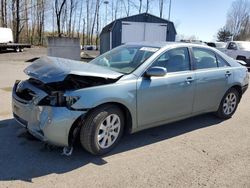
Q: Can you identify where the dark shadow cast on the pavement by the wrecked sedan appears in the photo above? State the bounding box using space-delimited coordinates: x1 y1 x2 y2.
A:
0 114 223 182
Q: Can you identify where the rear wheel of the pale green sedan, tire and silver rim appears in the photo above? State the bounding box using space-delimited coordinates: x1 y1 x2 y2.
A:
216 88 240 119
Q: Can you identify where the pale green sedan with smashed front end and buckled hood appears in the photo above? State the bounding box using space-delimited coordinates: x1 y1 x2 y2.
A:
12 42 249 155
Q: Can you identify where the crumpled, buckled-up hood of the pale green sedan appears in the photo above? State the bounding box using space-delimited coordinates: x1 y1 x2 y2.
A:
24 56 123 83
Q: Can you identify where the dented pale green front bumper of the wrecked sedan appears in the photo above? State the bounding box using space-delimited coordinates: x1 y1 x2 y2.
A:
12 83 86 146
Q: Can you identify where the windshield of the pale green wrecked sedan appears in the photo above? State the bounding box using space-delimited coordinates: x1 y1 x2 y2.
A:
89 45 159 74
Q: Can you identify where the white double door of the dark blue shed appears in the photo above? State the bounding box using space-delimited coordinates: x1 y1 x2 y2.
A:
122 22 167 44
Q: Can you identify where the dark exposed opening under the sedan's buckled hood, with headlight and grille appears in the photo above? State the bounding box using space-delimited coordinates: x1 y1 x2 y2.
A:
16 75 118 107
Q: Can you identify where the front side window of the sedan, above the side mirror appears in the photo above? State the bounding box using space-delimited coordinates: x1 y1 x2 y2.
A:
151 48 190 72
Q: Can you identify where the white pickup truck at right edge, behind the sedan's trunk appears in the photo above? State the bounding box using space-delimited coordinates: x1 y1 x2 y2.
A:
223 41 250 68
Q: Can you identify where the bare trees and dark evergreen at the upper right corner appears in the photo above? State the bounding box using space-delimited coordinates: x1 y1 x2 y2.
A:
217 0 250 42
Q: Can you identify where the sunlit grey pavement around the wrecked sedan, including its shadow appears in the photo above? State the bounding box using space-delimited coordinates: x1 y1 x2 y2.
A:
0 49 250 188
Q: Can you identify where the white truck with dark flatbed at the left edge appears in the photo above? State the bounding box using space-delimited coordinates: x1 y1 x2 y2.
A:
0 27 31 52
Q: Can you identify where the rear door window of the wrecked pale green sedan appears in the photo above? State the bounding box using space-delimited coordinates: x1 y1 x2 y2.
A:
193 48 217 69
